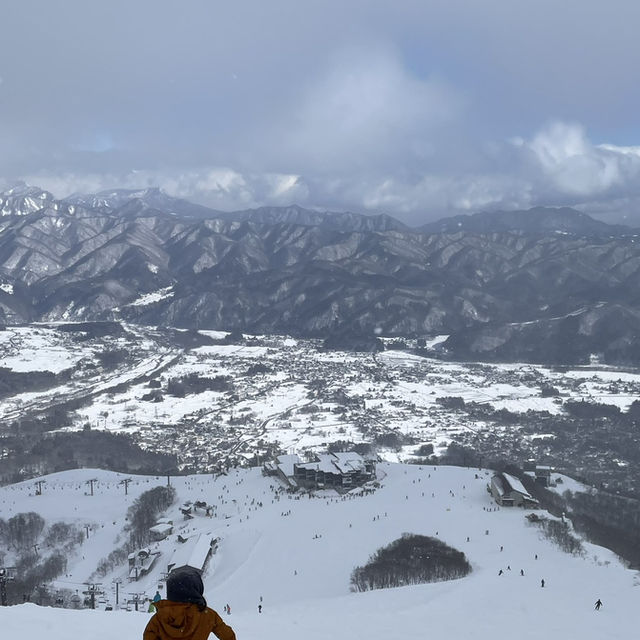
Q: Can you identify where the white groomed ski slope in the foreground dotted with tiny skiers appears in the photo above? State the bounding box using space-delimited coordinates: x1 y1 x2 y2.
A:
0 463 640 640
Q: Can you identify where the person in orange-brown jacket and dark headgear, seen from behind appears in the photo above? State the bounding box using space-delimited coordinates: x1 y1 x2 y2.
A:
142 567 236 640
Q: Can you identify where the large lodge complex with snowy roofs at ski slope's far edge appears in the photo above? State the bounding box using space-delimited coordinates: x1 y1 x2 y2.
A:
263 451 376 491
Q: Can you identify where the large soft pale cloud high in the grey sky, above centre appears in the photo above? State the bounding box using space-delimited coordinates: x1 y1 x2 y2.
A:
274 46 464 173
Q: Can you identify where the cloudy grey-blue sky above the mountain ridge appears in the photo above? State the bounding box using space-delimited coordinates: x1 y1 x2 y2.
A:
0 0 640 224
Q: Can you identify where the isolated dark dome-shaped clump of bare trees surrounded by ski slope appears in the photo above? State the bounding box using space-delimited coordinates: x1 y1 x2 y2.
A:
351 533 471 591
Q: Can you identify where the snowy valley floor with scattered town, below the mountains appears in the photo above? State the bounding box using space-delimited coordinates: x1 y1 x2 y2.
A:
0 325 640 470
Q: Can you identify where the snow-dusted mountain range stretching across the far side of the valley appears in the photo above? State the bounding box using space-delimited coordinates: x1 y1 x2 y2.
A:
0 185 640 362
